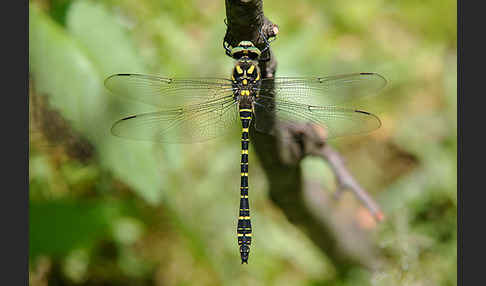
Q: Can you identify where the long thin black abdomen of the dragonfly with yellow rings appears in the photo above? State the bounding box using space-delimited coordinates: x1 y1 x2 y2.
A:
236 108 252 264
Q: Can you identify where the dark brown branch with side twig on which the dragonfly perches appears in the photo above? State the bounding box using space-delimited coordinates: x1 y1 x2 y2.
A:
224 0 382 275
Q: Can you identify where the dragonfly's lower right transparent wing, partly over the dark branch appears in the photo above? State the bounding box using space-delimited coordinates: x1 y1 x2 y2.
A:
255 98 381 139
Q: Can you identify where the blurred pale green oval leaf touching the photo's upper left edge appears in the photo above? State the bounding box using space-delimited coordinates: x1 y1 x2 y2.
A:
29 5 105 130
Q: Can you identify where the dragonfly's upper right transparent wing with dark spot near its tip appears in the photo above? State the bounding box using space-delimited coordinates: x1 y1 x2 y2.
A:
260 73 386 105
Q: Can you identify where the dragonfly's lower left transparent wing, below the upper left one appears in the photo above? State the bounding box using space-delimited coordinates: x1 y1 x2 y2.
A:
111 96 239 143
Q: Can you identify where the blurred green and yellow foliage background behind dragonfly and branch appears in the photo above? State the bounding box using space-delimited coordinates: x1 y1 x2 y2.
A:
29 0 457 286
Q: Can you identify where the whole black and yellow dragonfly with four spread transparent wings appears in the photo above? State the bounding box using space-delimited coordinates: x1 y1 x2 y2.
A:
105 41 386 264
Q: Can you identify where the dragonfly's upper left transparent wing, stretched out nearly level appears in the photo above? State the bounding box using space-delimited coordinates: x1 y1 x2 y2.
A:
105 74 233 107
